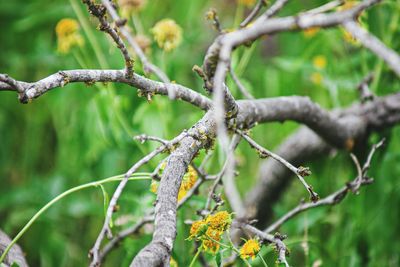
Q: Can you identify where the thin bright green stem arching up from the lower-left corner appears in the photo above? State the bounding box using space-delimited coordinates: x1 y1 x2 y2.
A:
0 173 151 263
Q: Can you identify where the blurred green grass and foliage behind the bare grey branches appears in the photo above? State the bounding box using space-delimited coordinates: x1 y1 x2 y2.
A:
0 0 400 266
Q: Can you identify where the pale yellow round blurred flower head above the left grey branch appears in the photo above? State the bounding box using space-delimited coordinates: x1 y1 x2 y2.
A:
151 19 182 52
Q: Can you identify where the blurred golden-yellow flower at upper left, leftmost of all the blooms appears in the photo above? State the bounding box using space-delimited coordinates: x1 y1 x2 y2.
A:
56 18 84 54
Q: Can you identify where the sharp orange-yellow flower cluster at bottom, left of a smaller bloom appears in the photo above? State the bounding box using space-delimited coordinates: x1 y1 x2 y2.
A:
188 211 232 254
